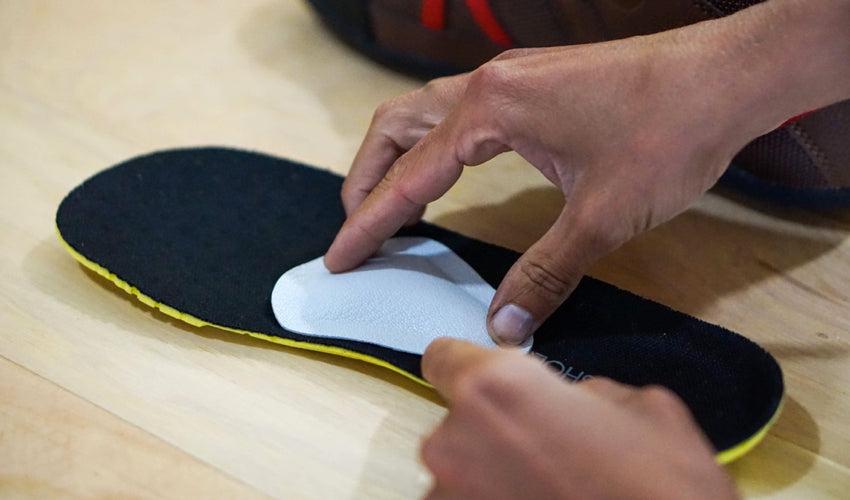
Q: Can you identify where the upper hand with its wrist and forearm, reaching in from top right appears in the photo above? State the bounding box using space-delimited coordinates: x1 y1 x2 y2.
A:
325 0 850 345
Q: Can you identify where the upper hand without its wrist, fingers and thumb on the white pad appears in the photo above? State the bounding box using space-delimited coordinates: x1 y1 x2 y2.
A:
325 34 740 344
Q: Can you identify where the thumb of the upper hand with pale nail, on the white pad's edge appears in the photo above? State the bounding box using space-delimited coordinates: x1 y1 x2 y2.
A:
487 209 598 345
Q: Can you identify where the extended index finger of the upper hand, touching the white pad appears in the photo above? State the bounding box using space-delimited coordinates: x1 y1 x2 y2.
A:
325 109 507 272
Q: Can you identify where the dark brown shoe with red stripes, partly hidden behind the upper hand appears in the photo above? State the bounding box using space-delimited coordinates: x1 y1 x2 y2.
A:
308 0 850 206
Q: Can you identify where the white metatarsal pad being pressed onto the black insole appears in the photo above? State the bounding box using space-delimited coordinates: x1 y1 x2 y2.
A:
272 237 528 354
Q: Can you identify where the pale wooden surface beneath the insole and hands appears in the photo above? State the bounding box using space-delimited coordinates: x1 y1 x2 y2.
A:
0 0 850 498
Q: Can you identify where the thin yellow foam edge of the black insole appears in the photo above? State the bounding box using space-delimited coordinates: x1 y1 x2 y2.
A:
56 227 784 464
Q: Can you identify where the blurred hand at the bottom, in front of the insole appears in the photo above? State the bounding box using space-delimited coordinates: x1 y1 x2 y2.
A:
421 338 737 499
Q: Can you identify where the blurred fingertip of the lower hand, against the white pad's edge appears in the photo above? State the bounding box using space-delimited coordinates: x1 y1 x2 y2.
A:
422 337 500 401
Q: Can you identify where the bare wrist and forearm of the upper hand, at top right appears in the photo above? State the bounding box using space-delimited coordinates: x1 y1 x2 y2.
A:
660 0 850 151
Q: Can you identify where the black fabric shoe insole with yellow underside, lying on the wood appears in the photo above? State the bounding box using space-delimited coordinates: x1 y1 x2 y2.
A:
56 148 783 462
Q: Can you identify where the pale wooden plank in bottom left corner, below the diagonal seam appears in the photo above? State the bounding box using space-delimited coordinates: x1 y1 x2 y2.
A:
0 357 263 498
